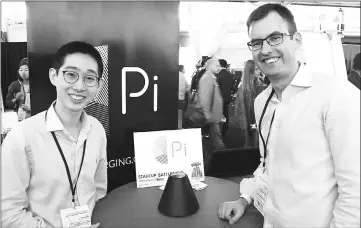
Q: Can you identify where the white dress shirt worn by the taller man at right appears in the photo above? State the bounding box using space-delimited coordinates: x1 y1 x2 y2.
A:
240 66 360 228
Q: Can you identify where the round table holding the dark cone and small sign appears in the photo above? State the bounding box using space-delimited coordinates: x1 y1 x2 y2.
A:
92 177 263 228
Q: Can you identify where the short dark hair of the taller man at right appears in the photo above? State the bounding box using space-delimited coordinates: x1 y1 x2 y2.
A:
247 3 297 34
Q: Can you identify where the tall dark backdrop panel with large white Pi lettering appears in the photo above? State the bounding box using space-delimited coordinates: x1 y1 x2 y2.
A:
27 2 179 190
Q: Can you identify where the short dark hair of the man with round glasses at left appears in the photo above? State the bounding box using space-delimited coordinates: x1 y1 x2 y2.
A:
52 41 104 78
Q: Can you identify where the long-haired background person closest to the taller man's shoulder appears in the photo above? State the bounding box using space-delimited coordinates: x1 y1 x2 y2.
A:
235 60 267 147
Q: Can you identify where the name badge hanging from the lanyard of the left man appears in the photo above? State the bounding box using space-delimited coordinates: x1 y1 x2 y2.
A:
60 205 91 228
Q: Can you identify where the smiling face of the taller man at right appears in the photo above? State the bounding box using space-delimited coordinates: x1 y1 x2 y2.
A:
249 12 302 79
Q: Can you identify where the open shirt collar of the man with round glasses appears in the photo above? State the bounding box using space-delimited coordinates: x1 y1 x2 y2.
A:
45 100 91 132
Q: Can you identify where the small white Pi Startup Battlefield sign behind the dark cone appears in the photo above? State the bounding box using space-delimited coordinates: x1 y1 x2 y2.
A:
134 128 205 188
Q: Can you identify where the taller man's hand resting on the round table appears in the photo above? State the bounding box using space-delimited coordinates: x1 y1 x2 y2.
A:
218 198 248 225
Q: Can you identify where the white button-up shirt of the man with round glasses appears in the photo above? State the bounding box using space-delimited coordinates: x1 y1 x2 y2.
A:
1 102 107 228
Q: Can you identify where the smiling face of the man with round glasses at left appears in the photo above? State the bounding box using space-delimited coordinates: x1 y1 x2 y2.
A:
49 53 103 112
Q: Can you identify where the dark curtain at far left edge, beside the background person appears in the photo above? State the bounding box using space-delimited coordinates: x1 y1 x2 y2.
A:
1 42 27 110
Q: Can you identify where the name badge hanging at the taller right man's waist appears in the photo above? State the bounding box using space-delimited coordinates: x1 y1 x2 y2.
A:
254 174 268 216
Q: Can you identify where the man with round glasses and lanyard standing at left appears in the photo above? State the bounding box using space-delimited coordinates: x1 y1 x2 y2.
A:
1 41 107 228
